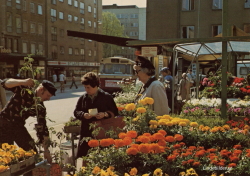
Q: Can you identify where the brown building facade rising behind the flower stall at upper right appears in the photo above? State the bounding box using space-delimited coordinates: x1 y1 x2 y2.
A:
146 0 250 40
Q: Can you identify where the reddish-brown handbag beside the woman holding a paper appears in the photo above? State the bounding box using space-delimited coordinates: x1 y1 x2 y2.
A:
92 117 125 139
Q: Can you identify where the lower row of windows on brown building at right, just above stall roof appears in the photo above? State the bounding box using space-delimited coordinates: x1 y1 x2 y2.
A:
181 24 250 38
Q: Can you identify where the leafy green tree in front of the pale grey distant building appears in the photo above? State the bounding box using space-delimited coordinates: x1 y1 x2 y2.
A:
102 12 127 58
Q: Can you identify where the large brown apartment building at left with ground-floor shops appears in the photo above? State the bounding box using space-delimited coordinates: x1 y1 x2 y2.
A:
0 0 102 79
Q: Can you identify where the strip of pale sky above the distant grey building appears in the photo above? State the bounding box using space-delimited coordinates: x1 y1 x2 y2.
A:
102 0 146 7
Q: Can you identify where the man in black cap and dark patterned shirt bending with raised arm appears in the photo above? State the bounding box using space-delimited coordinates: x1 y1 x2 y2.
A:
0 78 57 166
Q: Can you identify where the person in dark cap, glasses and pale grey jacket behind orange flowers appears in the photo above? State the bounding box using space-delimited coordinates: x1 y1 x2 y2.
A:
134 56 169 116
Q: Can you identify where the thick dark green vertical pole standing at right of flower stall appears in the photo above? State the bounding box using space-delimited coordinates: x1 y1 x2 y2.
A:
221 0 228 118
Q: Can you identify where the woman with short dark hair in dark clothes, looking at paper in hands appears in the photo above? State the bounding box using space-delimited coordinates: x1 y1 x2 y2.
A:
74 72 118 157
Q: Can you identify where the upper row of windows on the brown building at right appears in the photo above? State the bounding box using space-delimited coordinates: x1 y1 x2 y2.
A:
182 0 250 11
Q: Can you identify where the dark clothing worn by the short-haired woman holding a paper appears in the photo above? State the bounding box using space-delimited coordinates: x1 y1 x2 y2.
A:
74 89 118 157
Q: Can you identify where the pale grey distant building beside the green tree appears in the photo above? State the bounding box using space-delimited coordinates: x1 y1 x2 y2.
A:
103 4 146 60
